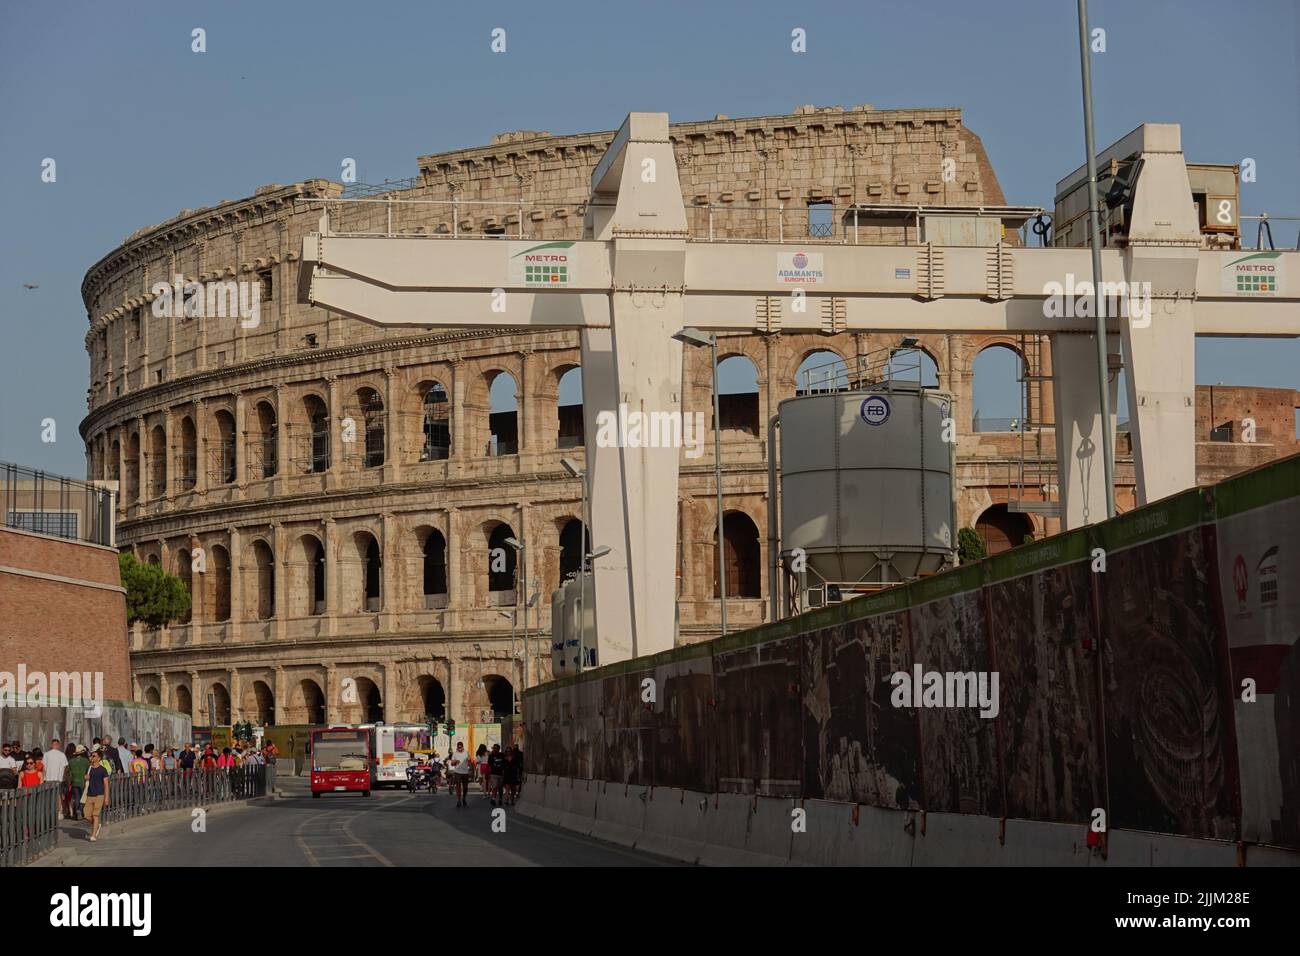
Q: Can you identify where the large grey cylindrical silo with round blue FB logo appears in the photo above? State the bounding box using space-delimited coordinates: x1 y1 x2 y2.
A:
780 381 957 609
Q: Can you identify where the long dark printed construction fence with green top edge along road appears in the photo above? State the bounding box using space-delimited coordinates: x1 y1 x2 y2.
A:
524 455 1300 849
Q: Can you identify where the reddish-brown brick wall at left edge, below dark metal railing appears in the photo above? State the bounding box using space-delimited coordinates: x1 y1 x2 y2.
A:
0 527 131 698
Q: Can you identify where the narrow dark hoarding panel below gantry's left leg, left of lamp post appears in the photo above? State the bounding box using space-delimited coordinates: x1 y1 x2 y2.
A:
655 654 716 793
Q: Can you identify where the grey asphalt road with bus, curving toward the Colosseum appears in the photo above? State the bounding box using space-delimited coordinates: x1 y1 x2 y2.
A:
33 777 673 866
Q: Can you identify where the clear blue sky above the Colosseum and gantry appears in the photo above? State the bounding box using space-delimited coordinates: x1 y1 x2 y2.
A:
0 0 1300 476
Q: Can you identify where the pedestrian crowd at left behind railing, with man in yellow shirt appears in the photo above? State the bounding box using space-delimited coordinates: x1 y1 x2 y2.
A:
0 737 280 842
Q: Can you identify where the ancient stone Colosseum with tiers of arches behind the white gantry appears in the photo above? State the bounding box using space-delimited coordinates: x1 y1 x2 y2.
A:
82 105 1296 724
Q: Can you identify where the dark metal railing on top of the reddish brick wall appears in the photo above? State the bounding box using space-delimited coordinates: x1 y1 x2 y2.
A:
0 462 114 546
